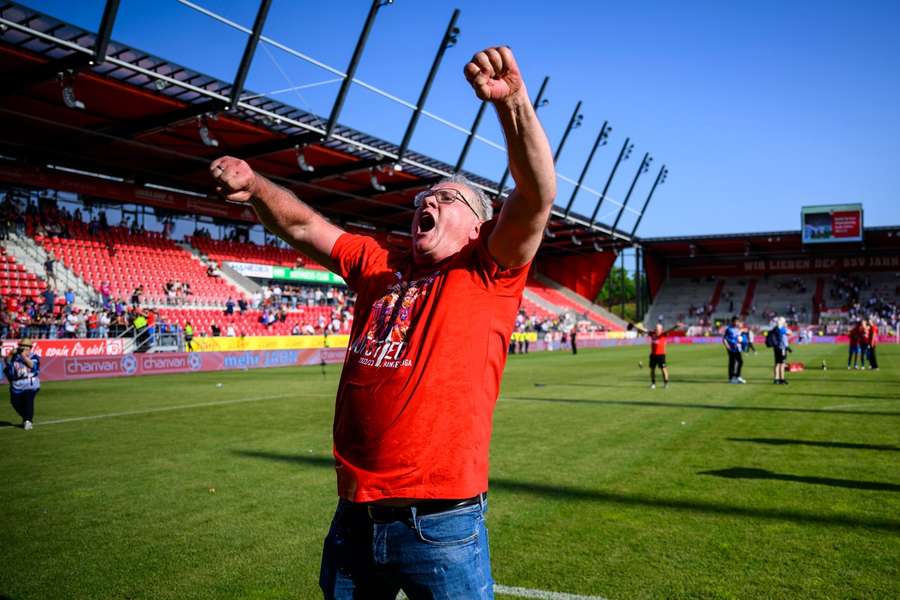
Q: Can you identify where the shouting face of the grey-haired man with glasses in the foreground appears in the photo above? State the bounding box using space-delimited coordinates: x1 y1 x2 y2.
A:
412 183 481 264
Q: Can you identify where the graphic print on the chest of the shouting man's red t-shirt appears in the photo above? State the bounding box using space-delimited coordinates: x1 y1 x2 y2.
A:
350 271 437 368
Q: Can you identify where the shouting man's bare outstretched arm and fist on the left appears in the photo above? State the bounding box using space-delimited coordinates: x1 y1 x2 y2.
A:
209 156 344 271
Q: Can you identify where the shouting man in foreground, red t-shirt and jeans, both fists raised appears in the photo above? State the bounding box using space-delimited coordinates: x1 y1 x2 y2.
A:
210 47 556 598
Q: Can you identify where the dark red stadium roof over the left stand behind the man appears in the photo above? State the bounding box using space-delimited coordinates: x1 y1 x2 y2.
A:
0 0 631 254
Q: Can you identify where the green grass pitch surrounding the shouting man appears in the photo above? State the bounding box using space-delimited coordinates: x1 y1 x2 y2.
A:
0 344 900 600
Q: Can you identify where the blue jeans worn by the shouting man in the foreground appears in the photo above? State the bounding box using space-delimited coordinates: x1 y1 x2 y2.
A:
319 500 494 600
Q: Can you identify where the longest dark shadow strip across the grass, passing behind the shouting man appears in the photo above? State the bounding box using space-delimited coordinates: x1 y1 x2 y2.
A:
232 450 900 532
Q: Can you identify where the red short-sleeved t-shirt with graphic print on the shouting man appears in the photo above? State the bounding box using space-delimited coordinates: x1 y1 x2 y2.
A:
331 226 529 502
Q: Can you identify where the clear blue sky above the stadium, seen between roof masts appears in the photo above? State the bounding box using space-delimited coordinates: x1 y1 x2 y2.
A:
15 0 900 236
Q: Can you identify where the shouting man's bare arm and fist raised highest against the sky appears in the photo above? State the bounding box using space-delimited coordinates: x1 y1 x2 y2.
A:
465 47 556 267
